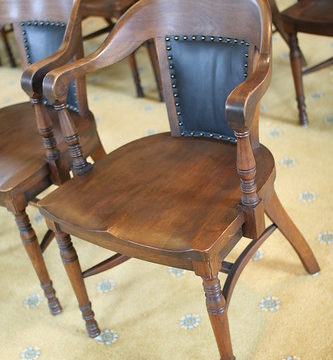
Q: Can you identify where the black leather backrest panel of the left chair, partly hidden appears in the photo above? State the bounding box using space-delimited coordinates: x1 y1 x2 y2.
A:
21 21 78 111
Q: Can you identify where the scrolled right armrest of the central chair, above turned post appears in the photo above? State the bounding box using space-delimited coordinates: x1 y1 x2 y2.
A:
226 54 272 131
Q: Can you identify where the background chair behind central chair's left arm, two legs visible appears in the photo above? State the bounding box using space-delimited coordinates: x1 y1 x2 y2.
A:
82 0 163 101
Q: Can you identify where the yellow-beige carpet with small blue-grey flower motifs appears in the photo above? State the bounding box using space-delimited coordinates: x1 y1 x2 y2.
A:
0 1 333 360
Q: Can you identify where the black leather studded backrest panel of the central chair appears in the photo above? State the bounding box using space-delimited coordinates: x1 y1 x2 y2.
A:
166 35 249 142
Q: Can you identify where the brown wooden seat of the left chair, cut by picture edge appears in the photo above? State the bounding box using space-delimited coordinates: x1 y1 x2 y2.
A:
0 103 96 197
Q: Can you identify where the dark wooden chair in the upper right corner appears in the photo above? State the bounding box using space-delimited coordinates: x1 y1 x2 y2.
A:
269 0 333 125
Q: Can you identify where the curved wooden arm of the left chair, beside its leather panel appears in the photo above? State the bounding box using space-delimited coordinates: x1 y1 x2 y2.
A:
21 0 81 98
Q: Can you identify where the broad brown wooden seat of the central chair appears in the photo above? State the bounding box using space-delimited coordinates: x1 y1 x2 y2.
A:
39 133 274 266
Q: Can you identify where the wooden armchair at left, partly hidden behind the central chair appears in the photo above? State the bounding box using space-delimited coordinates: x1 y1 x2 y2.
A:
0 0 104 315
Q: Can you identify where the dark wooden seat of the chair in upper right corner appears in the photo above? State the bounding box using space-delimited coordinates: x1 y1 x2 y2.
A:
281 0 333 36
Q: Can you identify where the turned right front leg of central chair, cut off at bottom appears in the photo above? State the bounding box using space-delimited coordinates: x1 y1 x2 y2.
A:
202 274 235 360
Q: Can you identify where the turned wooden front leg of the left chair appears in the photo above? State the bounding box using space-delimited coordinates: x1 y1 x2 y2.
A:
14 210 62 315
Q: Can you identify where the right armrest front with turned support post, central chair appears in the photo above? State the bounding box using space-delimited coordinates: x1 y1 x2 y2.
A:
226 54 272 239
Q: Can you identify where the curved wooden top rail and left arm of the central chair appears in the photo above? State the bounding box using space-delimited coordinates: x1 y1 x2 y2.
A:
44 0 271 128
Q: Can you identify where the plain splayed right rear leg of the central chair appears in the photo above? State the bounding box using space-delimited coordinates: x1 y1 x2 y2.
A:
265 191 320 274
